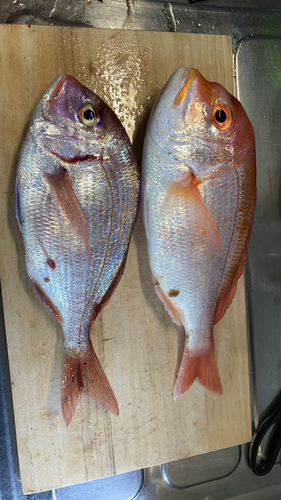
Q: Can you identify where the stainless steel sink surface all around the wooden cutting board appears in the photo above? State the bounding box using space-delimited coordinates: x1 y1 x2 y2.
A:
0 0 281 500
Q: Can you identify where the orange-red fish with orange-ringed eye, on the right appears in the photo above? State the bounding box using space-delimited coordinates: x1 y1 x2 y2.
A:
142 68 256 399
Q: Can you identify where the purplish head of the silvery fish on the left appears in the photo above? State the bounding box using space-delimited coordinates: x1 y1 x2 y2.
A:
31 75 124 163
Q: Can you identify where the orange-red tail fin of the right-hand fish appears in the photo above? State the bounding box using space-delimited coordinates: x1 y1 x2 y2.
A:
174 342 222 399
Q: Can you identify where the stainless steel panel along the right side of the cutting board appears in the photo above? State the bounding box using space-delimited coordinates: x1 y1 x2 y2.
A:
236 38 281 423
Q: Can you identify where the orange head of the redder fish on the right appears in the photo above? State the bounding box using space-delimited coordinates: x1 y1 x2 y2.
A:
149 68 255 179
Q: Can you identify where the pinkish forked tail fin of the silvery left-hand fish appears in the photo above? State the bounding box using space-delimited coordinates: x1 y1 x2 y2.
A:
62 341 119 426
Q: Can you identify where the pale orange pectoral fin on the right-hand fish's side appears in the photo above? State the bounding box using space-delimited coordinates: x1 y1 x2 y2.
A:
170 173 223 253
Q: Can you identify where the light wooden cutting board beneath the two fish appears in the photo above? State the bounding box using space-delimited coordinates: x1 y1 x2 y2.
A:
0 25 251 494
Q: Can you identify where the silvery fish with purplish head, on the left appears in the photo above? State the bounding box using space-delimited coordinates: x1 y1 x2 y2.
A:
15 75 140 426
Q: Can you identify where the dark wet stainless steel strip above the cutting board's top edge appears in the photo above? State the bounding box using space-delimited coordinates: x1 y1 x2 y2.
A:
0 0 281 47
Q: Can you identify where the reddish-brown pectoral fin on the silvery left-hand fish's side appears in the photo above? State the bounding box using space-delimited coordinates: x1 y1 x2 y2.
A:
45 168 91 260
